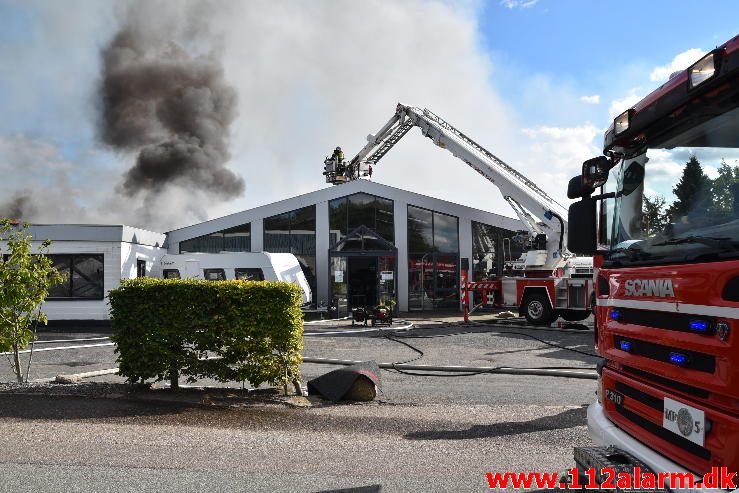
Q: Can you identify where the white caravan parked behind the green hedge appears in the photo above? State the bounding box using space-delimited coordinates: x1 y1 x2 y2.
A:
152 252 312 305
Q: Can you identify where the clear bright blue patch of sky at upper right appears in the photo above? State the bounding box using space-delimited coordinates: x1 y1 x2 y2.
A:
479 0 739 126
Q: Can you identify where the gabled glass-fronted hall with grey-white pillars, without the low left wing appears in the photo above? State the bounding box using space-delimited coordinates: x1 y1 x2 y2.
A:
167 180 523 311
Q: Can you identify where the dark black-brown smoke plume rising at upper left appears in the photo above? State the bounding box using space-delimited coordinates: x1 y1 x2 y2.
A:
100 3 244 199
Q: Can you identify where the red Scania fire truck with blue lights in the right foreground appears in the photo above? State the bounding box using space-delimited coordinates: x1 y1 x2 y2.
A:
568 36 739 486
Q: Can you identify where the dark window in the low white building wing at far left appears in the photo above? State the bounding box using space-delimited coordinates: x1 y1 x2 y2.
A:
49 254 104 300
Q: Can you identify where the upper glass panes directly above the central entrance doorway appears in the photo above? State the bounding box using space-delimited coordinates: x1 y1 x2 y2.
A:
328 193 395 247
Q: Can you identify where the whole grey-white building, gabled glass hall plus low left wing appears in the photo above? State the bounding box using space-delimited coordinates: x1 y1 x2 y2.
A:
5 180 523 322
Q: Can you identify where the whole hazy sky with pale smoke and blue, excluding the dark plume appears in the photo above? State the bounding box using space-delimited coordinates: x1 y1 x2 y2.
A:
0 0 739 230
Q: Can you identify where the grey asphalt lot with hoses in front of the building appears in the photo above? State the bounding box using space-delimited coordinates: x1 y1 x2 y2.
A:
0 317 597 492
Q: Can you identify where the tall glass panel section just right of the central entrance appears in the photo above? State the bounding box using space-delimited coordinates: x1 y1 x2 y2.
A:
408 205 459 310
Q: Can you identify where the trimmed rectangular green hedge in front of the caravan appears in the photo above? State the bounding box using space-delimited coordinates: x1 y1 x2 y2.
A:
109 278 303 386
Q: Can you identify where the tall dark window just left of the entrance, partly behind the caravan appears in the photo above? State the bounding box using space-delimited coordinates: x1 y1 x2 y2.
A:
264 205 316 293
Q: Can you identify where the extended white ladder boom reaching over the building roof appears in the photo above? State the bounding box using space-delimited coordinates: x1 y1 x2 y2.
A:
327 104 567 260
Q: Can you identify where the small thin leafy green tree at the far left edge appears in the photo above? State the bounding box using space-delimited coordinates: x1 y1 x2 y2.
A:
0 219 64 383
